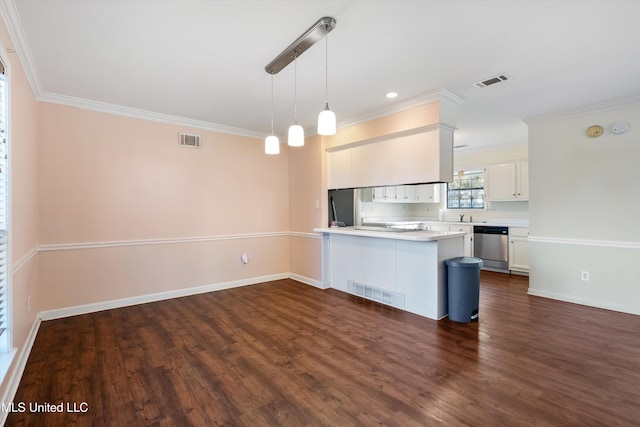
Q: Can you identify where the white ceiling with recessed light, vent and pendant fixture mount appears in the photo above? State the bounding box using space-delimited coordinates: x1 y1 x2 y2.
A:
2 0 640 147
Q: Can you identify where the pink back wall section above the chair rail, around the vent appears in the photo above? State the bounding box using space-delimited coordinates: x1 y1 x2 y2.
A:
39 103 289 244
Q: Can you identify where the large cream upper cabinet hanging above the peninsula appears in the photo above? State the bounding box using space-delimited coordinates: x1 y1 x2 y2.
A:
327 125 453 189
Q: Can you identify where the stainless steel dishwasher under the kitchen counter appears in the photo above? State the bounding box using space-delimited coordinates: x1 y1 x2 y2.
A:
473 225 509 272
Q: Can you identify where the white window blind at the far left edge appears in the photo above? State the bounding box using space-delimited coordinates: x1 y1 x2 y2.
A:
0 62 9 335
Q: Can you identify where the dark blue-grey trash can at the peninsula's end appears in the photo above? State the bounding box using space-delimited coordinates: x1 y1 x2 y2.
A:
445 256 482 322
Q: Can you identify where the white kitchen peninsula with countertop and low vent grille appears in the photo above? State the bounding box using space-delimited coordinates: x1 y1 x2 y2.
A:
314 227 465 320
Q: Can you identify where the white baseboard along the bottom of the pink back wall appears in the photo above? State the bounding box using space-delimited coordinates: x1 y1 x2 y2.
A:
40 273 289 320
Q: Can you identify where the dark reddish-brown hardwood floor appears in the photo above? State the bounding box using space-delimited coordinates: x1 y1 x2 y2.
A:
6 271 640 426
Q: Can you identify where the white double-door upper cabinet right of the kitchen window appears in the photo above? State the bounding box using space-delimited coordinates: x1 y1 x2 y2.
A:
485 162 529 202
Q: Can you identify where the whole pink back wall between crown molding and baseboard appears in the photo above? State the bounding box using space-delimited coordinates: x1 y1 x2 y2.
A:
39 103 289 310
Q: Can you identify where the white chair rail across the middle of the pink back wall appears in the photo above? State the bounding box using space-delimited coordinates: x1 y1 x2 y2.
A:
39 232 290 252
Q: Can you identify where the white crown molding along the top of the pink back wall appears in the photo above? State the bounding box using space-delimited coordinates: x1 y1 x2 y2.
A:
38 92 265 139
